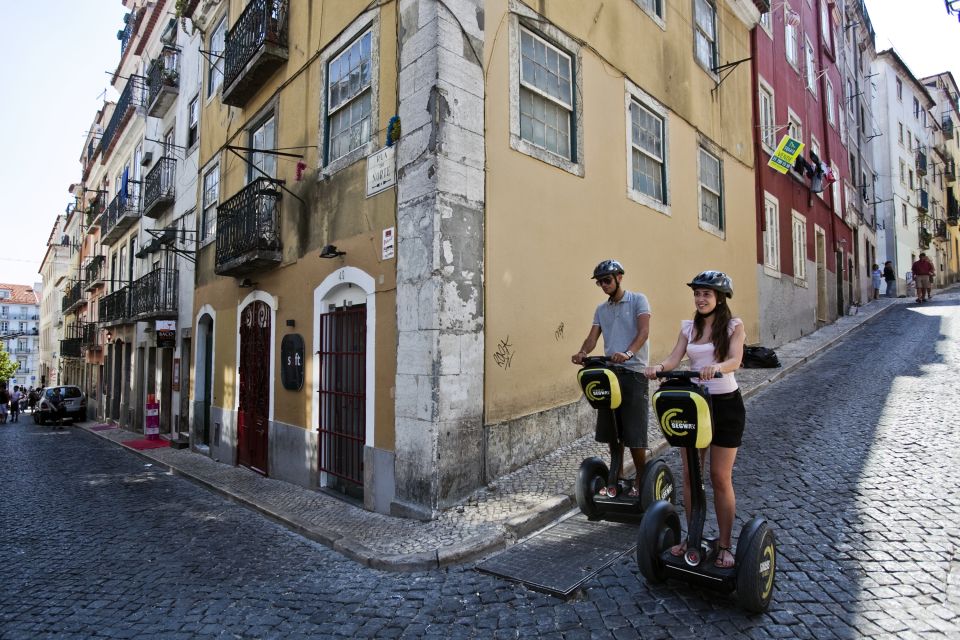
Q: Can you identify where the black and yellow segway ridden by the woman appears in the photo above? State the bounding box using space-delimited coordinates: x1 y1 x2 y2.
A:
637 371 777 612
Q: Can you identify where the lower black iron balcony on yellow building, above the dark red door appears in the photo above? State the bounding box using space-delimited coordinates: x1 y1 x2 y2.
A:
215 178 281 276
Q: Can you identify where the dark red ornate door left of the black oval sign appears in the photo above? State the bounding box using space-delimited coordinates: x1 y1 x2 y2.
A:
237 301 270 475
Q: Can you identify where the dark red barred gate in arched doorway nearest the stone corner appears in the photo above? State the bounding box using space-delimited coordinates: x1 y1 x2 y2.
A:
318 304 367 497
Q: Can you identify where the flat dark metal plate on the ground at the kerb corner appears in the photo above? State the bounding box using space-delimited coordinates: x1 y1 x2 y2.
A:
476 514 637 598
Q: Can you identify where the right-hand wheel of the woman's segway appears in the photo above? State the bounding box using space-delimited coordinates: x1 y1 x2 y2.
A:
737 518 777 613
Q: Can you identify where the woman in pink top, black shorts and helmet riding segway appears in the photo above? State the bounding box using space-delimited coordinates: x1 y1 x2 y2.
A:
643 271 746 568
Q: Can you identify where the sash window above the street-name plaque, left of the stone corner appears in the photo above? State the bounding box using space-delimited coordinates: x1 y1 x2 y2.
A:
327 30 373 164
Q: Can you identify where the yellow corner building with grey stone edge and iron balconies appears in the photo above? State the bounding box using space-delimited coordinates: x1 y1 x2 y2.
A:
184 0 760 517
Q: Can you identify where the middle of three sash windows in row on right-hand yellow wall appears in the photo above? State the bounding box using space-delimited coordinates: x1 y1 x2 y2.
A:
630 100 667 203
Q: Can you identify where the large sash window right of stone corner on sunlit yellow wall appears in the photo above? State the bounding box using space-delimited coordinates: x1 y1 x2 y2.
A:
520 29 573 160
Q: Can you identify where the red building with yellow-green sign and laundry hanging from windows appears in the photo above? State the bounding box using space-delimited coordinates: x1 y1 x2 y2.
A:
752 0 861 346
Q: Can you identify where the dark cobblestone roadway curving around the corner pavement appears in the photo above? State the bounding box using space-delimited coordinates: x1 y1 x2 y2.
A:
0 292 960 638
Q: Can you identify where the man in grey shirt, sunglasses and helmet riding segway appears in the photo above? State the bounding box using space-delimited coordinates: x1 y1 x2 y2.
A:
570 260 650 498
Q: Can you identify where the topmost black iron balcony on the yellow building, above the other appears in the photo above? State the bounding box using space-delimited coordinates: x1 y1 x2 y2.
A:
221 0 288 107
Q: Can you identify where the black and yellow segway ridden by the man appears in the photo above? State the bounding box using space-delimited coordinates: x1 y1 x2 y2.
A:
576 356 676 522
